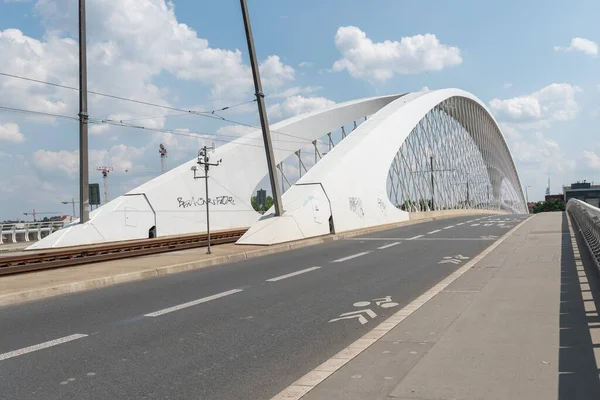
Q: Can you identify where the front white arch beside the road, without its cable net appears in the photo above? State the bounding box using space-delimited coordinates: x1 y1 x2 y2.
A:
238 89 526 244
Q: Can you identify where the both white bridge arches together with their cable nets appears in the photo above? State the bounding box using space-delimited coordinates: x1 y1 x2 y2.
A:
31 89 527 248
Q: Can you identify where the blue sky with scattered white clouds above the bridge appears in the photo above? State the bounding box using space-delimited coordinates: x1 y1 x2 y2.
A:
0 0 600 219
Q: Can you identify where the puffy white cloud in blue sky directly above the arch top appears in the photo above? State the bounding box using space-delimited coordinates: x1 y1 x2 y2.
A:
332 26 462 83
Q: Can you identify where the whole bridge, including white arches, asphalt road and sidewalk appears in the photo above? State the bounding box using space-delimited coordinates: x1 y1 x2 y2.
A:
0 89 600 400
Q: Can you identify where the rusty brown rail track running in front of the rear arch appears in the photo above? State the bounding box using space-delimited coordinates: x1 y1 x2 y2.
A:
0 229 246 276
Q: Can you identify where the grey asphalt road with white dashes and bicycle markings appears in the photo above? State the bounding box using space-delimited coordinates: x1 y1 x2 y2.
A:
0 215 527 400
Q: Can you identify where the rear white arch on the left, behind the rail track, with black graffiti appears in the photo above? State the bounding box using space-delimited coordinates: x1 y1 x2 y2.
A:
29 95 401 249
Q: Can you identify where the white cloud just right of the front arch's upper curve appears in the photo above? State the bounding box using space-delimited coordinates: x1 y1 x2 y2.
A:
490 83 581 123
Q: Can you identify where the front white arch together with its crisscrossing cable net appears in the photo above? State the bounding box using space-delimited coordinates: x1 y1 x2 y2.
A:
239 89 527 244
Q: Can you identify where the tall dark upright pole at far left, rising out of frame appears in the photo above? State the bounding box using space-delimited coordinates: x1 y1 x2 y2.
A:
79 0 90 224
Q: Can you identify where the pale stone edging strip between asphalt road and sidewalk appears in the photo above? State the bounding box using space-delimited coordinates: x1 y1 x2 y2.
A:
271 216 525 400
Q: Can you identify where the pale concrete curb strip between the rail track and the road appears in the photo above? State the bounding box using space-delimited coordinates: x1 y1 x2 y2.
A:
0 211 504 307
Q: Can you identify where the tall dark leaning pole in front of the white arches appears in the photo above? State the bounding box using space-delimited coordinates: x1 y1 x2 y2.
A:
240 0 283 217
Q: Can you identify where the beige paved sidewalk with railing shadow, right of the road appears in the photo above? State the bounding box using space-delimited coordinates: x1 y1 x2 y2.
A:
296 213 600 400
